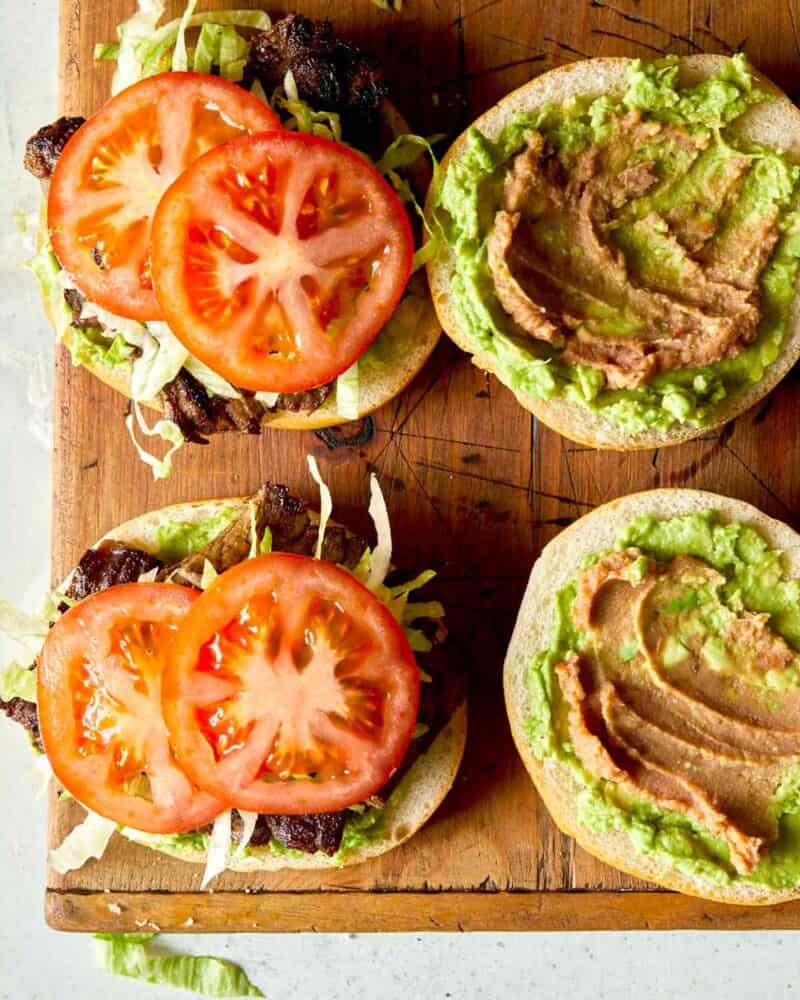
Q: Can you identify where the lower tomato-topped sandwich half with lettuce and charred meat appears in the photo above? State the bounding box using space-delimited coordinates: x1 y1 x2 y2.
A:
0 459 466 885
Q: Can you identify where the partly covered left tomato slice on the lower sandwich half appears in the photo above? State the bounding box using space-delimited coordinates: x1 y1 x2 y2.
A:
37 583 224 833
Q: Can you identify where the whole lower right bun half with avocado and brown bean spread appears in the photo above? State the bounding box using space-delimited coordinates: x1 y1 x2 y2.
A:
504 489 800 904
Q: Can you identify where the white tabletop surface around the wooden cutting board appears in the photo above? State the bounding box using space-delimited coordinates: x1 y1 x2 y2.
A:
0 0 800 1000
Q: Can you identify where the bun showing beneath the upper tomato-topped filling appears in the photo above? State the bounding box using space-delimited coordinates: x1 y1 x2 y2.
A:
42 101 441 430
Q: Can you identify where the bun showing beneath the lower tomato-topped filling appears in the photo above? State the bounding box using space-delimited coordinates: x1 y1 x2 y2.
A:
67 497 467 871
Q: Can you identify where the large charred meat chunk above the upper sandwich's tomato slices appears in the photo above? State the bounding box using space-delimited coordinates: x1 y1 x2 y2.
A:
245 14 389 151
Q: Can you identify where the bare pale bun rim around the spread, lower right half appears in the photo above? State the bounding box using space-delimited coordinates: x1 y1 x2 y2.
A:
503 489 800 905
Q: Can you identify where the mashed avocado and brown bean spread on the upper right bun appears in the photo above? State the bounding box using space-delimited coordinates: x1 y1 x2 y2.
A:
434 54 800 434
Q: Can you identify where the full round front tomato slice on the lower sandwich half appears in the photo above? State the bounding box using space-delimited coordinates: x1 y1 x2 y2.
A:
164 553 419 815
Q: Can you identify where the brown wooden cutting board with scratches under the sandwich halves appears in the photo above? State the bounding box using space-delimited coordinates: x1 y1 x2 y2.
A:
46 0 800 931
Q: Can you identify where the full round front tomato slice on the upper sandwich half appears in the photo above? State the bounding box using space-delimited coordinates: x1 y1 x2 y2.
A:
153 132 414 392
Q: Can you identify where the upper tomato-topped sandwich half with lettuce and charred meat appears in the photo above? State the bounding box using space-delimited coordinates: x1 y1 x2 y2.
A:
25 0 440 476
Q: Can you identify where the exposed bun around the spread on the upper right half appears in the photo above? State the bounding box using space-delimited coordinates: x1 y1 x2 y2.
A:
426 55 800 451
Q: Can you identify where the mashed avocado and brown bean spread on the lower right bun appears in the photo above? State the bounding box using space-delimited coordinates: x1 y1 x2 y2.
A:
528 510 800 889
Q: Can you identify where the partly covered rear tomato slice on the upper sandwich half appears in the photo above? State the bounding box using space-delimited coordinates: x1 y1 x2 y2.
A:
47 73 278 320
